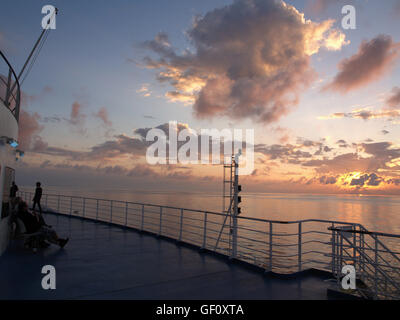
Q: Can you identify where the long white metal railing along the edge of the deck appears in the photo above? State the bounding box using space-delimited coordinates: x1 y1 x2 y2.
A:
20 192 400 299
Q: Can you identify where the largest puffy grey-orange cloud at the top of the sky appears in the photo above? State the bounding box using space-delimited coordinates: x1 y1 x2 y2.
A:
144 0 347 123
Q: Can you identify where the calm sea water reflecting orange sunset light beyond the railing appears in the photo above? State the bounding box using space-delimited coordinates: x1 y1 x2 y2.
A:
28 187 400 234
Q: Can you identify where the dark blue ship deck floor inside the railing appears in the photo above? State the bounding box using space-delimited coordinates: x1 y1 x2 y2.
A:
0 214 329 300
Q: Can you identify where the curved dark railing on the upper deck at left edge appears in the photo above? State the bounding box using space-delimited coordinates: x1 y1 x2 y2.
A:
0 51 21 121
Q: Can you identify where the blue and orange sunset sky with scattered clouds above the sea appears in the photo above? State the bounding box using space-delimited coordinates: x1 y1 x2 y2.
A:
0 0 400 194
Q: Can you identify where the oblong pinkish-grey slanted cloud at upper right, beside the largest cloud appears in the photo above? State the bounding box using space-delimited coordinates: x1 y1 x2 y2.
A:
324 35 399 93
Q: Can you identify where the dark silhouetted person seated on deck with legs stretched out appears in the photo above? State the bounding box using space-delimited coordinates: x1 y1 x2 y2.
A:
17 201 69 248
